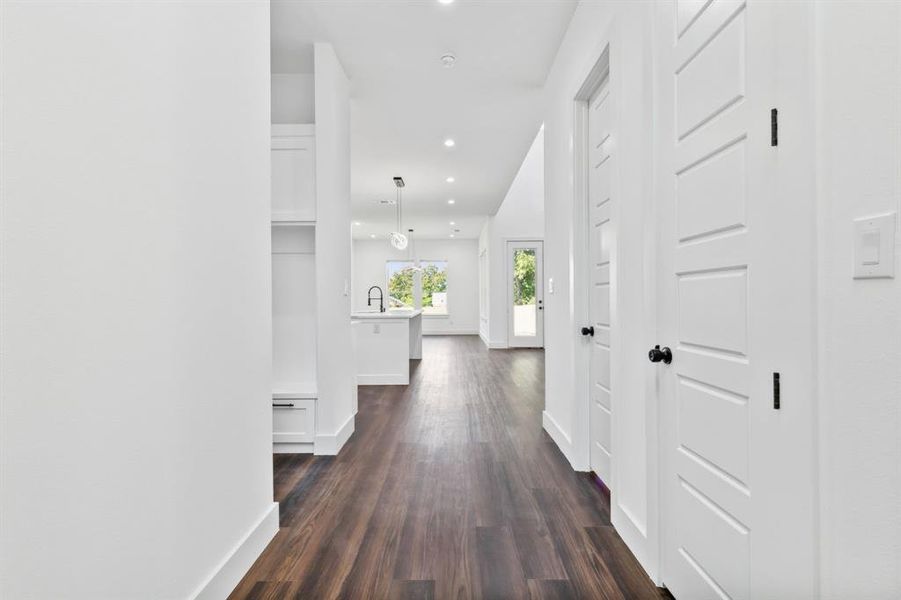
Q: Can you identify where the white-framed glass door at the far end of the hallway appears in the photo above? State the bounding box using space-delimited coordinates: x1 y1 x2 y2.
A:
507 241 544 348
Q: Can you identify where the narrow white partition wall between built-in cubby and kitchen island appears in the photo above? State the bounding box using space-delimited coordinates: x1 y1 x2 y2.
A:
311 43 357 454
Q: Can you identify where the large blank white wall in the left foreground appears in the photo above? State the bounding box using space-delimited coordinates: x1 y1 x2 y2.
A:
0 2 278 600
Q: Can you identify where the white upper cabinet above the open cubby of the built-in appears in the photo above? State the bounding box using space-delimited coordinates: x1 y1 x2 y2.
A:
271 125 316 223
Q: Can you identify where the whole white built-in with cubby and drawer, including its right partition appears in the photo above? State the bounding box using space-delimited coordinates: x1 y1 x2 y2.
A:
270 43 356 455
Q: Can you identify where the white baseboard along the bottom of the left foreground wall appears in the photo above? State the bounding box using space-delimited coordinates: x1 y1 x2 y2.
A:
190 502 278 600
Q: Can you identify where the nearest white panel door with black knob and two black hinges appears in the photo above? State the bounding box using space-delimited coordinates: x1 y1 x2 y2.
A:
649 0 815 600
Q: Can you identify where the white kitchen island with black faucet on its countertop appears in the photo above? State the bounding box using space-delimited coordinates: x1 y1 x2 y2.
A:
350 309 422 385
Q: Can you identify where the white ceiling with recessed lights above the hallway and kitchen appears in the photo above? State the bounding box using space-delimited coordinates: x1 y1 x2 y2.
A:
272 0 576 238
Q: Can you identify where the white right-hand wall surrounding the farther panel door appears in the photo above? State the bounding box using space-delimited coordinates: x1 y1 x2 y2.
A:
544 2 659 578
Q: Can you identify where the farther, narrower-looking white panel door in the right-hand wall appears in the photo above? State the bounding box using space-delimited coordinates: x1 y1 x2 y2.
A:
587 81 613 486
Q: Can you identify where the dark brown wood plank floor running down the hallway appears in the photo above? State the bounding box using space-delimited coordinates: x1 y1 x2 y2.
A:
231 336 668 600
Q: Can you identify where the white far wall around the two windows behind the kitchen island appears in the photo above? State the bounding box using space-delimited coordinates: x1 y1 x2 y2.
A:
352 238 479 335
